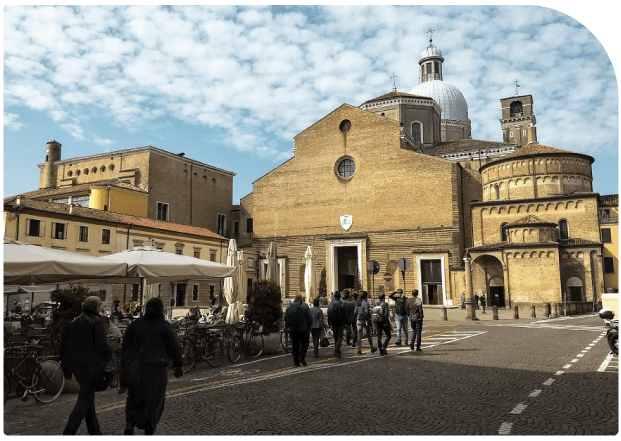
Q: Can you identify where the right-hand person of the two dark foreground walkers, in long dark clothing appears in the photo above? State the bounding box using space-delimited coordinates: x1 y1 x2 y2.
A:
121 297 183 436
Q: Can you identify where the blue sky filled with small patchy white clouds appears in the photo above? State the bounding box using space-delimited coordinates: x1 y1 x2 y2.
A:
2 5 619 204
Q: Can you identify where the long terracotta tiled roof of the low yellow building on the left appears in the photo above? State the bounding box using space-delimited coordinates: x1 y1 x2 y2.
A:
4 197 226 239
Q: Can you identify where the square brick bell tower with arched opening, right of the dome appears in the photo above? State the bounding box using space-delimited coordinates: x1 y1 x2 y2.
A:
500 80 537 145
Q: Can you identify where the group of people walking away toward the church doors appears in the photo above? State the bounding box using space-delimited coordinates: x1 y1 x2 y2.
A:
285 289 424 366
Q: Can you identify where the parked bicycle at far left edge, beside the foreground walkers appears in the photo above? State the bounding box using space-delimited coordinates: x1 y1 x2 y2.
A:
3 345 65 404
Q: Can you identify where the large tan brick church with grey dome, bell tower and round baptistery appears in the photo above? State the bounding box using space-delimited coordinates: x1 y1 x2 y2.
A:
233 44 618 307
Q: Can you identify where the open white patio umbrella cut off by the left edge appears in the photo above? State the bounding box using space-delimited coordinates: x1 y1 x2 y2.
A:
2 239 127 285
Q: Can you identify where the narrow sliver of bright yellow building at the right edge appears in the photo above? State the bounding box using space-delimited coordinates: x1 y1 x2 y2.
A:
599 194 619 293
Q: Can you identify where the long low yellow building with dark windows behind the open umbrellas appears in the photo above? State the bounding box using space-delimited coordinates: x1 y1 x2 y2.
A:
3 196 228 310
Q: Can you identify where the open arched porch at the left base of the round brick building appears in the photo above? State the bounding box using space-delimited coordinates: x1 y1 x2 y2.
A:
472 254 507 308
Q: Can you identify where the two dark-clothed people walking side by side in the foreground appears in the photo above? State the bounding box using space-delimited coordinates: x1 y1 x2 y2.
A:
60 296 183 436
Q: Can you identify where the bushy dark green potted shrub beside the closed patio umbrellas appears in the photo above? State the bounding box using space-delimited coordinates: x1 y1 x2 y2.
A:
245 280 283 354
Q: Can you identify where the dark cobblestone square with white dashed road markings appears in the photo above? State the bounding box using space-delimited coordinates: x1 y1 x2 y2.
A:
3 311 619 436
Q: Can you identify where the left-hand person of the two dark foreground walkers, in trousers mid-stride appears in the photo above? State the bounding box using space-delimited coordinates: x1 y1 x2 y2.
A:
59 296 111 436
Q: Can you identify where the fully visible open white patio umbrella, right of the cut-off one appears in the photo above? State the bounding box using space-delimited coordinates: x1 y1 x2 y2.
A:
100 246 236 310
